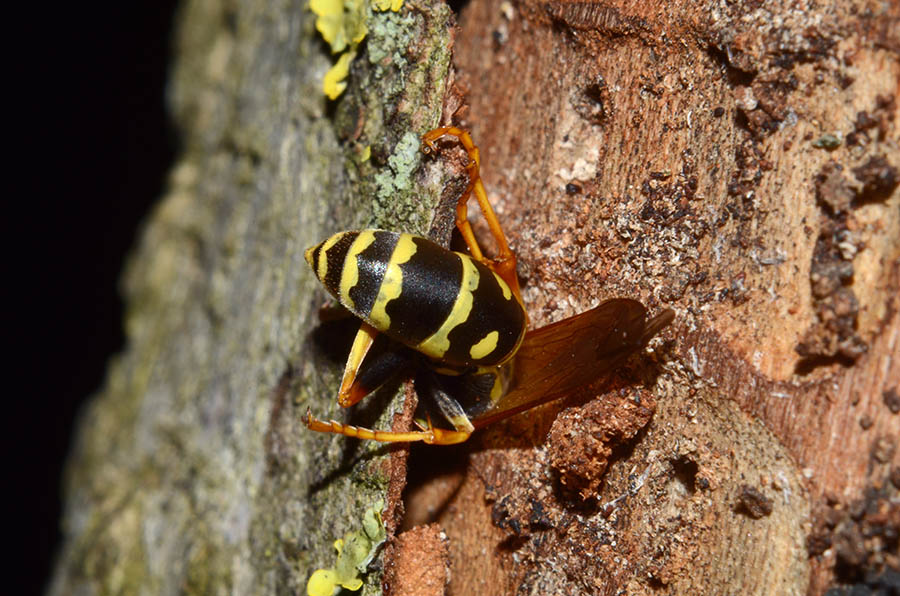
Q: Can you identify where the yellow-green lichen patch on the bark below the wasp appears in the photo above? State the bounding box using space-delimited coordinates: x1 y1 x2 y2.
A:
306 500 387 596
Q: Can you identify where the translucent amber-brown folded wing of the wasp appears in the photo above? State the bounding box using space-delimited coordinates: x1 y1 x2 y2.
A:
472 298 675 428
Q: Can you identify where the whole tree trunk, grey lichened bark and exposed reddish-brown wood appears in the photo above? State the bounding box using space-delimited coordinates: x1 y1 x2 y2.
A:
51 0 900 594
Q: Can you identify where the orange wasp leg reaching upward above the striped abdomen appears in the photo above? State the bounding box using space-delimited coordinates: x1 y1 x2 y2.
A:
422 126 522 303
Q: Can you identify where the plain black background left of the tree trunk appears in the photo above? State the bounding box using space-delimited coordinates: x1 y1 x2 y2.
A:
14 0 177 594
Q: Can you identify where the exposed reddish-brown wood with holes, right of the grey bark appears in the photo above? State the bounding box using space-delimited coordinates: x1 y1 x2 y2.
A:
407 0 900 594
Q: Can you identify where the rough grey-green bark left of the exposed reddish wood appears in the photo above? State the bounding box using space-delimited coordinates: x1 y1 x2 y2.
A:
49 0 453 594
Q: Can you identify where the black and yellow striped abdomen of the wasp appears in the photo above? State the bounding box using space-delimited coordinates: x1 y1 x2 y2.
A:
306 230 526 366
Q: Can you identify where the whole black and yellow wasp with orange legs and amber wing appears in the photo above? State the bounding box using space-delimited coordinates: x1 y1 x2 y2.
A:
304 127 674 445
